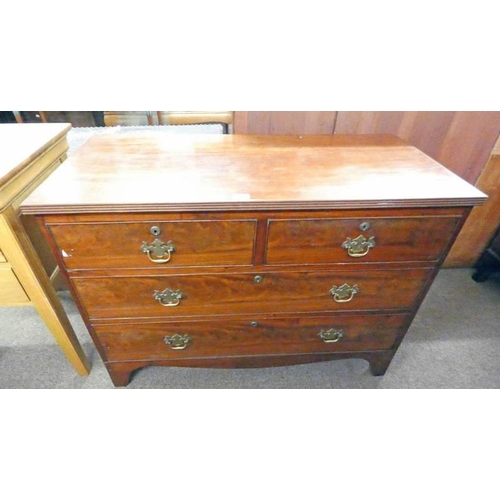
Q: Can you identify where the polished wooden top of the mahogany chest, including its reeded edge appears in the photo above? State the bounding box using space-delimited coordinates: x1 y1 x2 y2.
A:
21 130 486 214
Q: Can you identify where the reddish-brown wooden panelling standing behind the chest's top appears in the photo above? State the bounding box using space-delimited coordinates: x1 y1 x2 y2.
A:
235 111 500 184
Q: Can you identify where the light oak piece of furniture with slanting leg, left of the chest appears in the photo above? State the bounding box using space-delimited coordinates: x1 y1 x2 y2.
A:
0 123 90 375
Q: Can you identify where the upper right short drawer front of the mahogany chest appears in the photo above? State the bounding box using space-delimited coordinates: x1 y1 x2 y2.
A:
266 216 460 264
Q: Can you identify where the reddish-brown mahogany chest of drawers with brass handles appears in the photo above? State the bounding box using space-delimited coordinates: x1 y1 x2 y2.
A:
22 131 486 385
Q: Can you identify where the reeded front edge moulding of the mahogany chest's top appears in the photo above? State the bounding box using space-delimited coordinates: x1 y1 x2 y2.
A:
20 196 487 215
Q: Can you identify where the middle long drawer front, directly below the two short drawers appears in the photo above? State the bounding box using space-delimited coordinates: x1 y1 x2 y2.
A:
73 269 432 318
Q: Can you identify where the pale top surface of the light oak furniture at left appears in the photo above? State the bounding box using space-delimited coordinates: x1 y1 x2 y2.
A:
0 123 71 189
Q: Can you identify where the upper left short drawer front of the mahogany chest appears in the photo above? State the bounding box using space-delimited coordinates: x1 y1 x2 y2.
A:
48 220 257 270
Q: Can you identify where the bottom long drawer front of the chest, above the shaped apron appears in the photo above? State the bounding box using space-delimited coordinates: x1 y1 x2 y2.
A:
95 315 408 361
